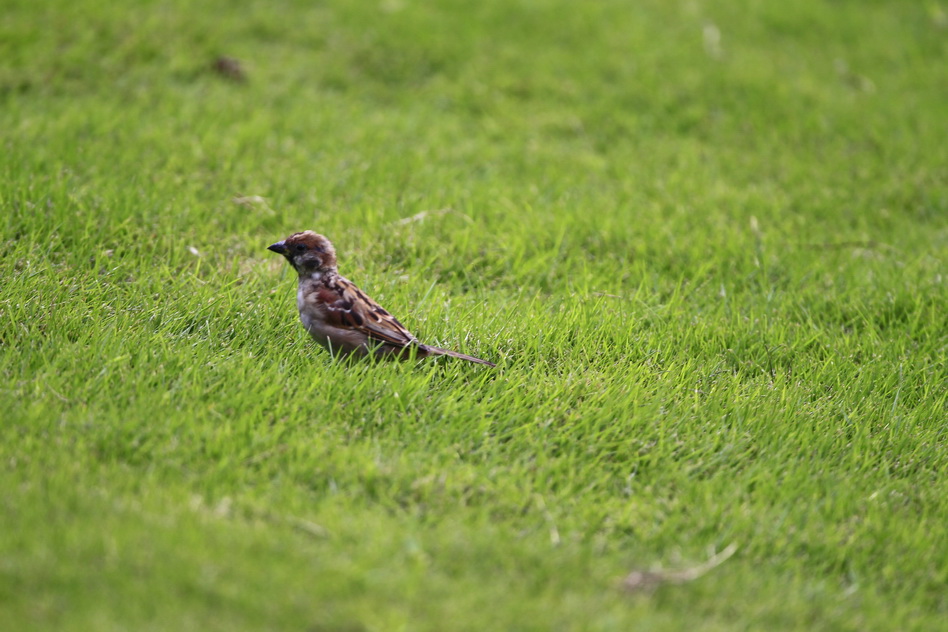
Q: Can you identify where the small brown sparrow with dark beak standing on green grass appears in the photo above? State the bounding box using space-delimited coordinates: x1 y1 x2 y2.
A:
267 230 496 366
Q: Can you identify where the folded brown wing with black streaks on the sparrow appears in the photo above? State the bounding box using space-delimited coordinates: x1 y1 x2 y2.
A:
321 277 417 347
